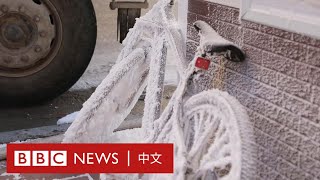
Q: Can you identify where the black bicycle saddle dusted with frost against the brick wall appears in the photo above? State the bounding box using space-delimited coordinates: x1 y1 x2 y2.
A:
193 21 246 62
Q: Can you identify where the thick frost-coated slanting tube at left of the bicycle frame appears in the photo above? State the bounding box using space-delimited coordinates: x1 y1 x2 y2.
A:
63 48 148 143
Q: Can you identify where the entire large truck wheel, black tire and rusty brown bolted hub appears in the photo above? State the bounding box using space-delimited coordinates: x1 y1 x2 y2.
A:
0 0 97 105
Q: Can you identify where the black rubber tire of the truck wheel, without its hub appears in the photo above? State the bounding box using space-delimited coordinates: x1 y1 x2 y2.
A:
0 0 97 105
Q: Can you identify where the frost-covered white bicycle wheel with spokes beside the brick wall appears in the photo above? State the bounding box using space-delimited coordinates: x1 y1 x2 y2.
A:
180 90 255 180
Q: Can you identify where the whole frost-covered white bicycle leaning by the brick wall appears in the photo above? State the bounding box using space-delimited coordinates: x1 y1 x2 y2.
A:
63 0 255 180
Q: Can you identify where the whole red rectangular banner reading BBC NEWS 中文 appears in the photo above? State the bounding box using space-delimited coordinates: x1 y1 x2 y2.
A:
7 144 174 173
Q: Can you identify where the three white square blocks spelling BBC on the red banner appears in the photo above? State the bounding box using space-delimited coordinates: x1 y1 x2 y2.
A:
14 151 67 167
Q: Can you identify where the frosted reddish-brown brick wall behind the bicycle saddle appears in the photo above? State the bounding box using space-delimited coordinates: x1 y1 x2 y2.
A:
187 0 320 180
